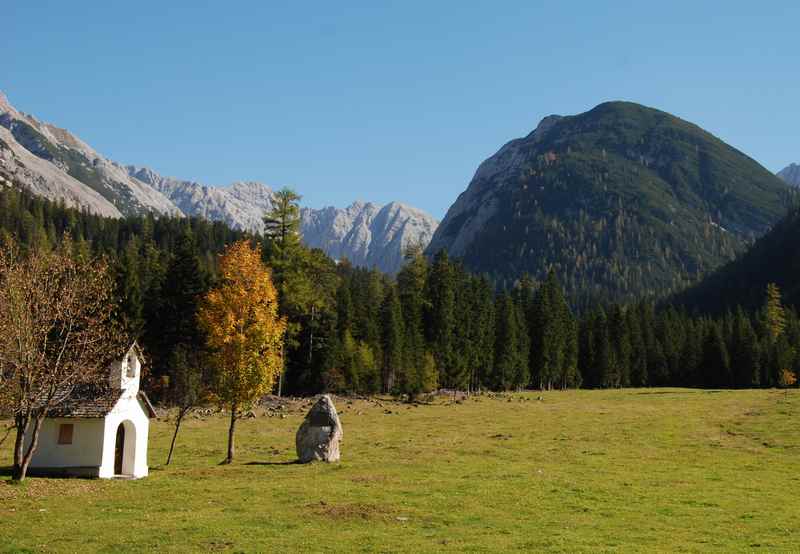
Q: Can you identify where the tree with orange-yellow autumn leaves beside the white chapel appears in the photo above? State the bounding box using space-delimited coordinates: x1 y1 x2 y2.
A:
198 240 286 463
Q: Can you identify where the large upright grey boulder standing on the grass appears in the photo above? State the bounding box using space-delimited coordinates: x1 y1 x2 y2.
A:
295 394 342 464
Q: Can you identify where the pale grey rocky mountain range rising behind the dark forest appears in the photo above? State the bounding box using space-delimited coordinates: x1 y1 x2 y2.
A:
0 93 438 273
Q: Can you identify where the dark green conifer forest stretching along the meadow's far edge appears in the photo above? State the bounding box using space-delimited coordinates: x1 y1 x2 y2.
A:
0 184 800 400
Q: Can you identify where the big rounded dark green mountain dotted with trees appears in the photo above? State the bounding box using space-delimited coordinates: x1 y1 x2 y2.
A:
427 102 790 304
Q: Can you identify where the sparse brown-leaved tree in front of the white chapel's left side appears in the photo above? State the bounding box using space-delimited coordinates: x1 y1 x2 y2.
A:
0 237 124 480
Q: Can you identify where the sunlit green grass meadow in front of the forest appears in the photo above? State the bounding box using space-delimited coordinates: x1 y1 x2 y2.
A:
0 389 800 552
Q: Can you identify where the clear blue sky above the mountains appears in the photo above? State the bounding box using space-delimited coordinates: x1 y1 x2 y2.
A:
0 0 800 217
